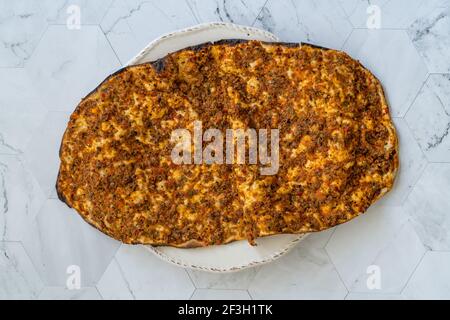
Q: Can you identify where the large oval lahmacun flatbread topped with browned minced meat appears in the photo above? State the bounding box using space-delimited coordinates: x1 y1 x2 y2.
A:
57 40 398 247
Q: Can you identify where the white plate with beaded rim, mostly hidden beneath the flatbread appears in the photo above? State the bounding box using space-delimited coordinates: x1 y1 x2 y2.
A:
128 22 306 272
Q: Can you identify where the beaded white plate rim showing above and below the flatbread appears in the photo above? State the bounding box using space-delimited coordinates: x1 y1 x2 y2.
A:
125 22 309 273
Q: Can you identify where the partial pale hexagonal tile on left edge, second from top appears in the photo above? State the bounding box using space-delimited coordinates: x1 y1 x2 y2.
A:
0 68 47 154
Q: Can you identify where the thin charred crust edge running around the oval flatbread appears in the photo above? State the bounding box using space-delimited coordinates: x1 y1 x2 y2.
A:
55 39 399 249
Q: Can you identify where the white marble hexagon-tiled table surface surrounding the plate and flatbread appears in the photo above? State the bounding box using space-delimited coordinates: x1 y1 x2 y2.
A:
0 0 450 299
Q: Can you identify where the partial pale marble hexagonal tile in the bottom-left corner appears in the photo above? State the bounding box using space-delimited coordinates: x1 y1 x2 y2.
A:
0 242 43 300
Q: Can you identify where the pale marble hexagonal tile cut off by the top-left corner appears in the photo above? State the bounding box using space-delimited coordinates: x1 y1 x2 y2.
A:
0 0 47 67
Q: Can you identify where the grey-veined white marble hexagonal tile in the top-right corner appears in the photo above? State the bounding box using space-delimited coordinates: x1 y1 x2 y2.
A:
408 1 450 73
